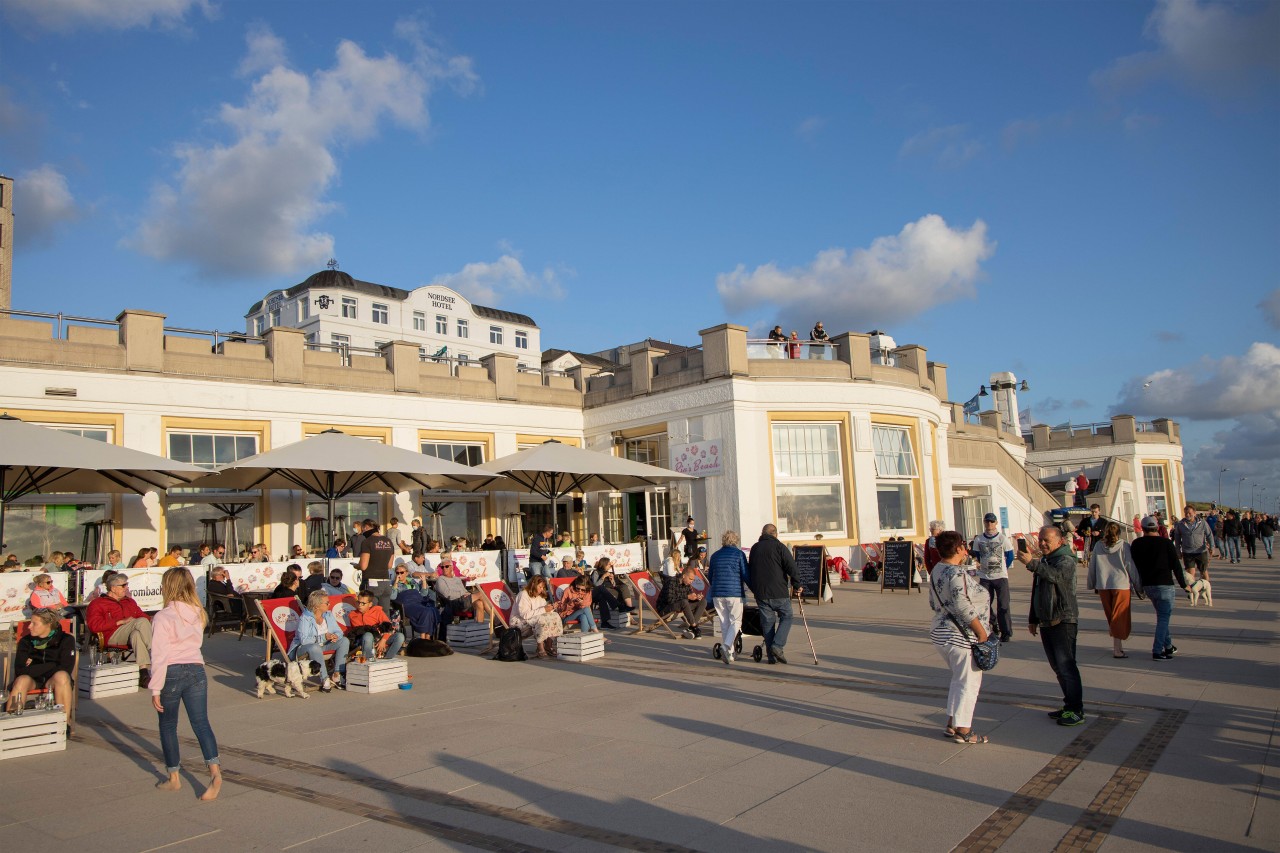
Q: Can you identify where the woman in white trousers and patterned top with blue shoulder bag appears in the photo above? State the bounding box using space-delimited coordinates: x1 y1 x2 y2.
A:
929 530 991 743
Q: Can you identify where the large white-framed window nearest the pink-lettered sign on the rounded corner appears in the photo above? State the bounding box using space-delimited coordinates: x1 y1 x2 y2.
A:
773 424 845 535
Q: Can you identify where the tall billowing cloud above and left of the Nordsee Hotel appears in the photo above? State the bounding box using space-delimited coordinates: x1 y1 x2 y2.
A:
127 28 474 275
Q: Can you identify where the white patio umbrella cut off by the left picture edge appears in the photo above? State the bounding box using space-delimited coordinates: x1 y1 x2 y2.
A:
0 412 207 543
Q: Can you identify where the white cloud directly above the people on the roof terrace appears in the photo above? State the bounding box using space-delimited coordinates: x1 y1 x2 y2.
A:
716 214 996 329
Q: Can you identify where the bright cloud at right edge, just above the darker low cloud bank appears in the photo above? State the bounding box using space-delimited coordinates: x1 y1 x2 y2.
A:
1114 342 1280 420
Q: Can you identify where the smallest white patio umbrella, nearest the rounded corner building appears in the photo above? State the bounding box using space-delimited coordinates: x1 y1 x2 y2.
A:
474 439 696 537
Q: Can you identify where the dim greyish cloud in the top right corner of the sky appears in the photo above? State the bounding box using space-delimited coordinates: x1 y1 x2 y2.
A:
1093 0 1280 95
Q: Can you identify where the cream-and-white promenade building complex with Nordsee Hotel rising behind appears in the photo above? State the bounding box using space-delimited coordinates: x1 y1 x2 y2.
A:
0 270 1183 564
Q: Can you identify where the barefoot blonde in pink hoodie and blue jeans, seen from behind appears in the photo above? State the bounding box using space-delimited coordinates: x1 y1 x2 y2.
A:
150 566 223 800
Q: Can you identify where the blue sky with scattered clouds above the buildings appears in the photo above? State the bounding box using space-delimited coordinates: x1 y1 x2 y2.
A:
0 0 1280 508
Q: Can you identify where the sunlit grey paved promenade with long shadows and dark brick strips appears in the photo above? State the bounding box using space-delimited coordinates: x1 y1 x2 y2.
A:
0 560 1280 853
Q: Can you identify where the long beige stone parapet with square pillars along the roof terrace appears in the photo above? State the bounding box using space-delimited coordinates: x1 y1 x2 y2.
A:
0 309 947 407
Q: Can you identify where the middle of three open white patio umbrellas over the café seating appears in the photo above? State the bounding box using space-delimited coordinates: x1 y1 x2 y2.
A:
195 429 502 542
